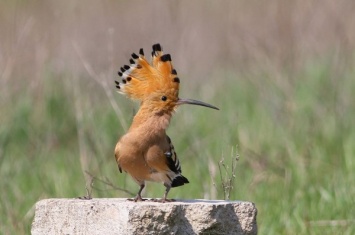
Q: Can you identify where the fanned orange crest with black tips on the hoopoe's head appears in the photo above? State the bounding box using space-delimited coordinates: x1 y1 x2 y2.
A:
115 44 180 101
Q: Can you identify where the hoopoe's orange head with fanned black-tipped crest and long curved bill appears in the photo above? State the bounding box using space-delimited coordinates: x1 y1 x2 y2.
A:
115 44 218 114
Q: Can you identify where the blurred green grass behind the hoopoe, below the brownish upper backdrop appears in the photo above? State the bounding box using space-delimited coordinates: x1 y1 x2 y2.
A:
0 57 355 234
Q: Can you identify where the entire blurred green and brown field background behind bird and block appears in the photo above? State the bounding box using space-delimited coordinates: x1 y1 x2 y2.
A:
0 0 355 234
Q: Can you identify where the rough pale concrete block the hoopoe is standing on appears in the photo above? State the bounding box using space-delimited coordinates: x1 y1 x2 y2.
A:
31 198 257 235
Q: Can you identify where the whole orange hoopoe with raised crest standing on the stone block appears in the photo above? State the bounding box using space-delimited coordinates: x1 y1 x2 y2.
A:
115 44 218 202
